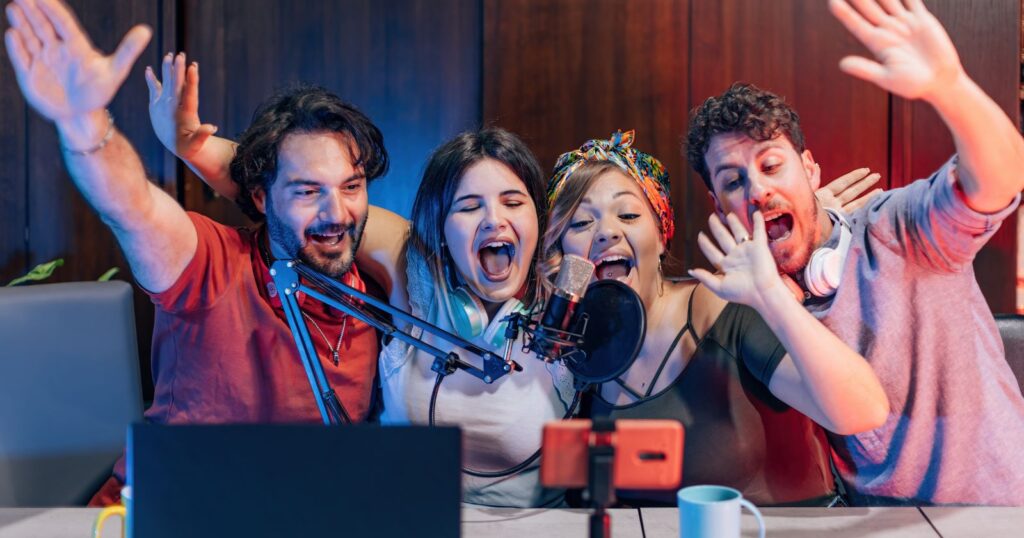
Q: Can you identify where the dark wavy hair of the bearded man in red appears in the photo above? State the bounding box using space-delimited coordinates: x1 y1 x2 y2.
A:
230 84 388 222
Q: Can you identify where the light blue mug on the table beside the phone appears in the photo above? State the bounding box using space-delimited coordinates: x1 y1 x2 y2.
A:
676 486 765 538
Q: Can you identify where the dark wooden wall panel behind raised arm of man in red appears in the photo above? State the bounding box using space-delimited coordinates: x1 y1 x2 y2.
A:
13 0 176 398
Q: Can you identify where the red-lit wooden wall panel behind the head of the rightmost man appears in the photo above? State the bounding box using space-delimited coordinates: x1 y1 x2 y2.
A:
677 0 889 265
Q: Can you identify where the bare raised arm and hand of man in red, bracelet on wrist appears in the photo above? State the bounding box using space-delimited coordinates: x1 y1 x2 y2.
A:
4 0 197 292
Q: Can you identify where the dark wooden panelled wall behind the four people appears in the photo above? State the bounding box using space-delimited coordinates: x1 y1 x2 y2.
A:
0 0 1021 395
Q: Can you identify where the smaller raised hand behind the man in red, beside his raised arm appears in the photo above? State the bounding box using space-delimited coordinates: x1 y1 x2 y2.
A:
145 52 217 161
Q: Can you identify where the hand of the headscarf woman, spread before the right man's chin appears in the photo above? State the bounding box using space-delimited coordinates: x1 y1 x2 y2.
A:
689 211 784 312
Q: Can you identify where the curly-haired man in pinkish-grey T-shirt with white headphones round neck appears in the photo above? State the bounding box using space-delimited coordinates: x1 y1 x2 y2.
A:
687 0 1024 505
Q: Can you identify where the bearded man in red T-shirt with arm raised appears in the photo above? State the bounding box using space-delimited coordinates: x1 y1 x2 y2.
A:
5 0 388 505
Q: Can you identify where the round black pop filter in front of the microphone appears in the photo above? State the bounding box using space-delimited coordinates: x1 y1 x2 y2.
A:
564 280 647 383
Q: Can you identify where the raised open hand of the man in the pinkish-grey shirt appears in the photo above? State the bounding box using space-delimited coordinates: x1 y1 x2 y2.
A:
828 0 964 100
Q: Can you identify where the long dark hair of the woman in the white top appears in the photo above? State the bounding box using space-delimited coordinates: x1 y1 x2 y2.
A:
410 127 548 305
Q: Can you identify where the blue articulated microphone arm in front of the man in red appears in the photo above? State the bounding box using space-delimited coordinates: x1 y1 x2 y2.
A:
270 260 522 424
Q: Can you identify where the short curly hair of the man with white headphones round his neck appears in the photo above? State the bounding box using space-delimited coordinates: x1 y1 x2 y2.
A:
686 82 805 193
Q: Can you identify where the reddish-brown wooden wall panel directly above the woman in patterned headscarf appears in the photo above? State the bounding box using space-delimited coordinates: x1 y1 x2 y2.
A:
483 0 688 270
